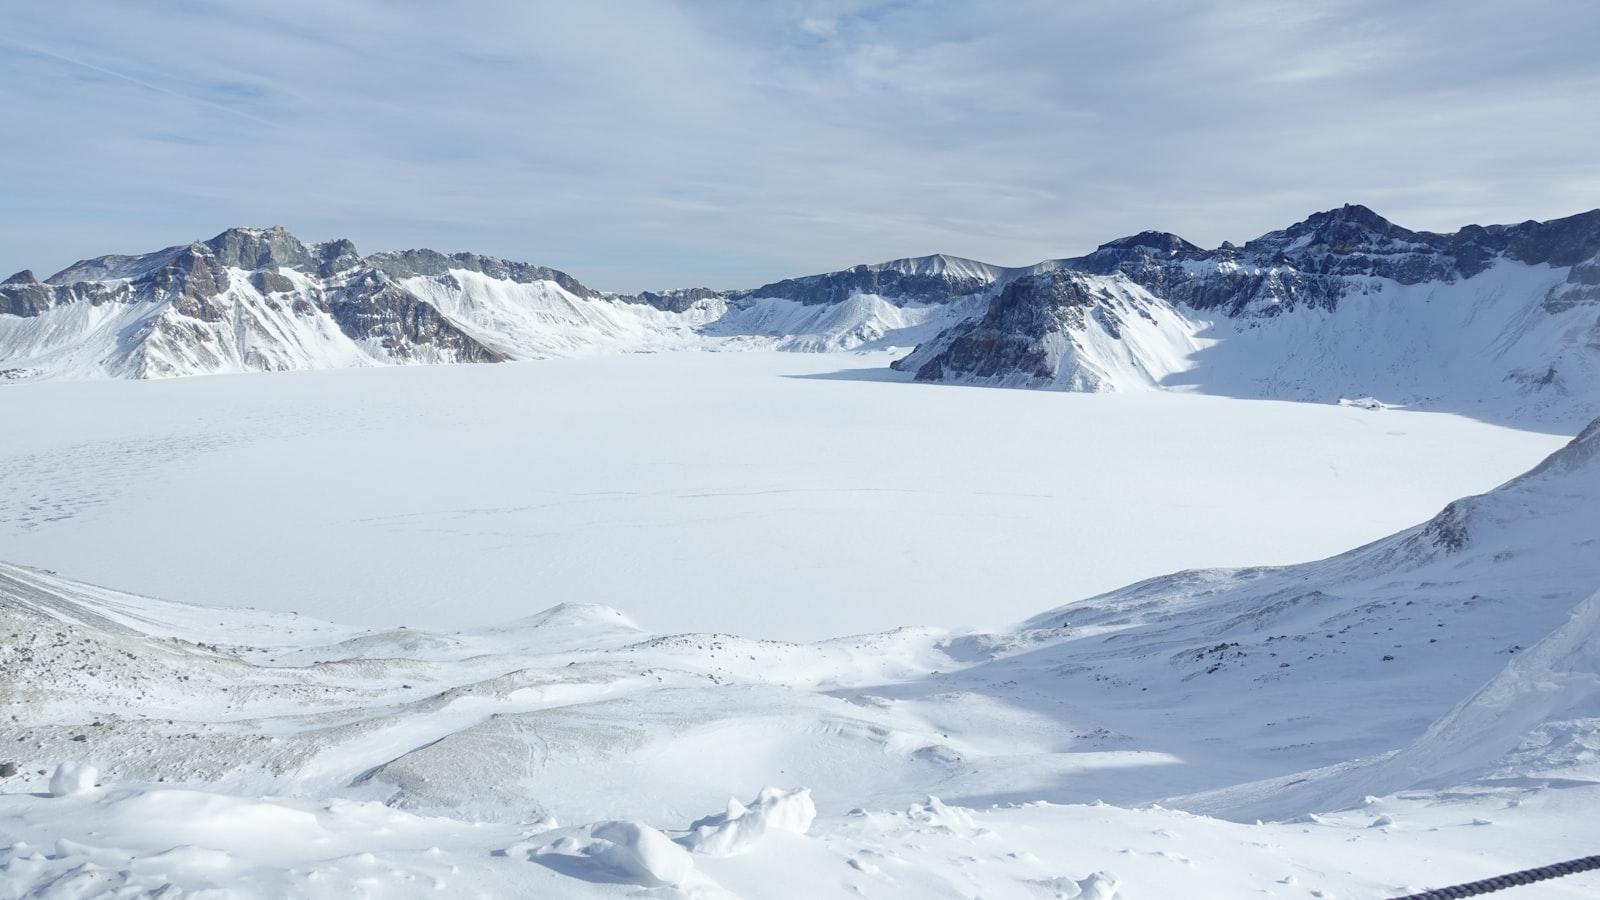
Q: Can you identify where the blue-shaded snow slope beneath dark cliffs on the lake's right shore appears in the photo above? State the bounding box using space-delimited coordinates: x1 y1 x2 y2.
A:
1165 261 1600 421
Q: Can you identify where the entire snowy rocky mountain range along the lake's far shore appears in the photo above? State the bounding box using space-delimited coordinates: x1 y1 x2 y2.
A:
0 205 1600 429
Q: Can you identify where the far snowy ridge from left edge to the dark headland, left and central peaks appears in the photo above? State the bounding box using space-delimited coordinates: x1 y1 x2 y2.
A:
0 227 995 380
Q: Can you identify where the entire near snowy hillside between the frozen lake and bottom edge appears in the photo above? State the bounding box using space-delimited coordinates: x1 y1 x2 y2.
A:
0 423 1600 900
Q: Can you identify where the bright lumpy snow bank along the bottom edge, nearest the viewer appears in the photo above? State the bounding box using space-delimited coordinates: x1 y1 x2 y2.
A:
12 783 1600 900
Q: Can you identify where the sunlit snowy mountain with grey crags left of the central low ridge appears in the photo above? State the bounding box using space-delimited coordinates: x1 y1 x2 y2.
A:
0 227 700 378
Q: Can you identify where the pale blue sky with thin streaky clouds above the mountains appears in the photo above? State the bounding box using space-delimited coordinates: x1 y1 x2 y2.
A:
0 0 1600 291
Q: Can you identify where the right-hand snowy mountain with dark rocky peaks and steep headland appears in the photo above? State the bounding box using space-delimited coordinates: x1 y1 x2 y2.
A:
896 207 1600 424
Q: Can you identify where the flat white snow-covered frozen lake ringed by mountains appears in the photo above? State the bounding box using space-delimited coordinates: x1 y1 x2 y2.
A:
0 352 1568 639
